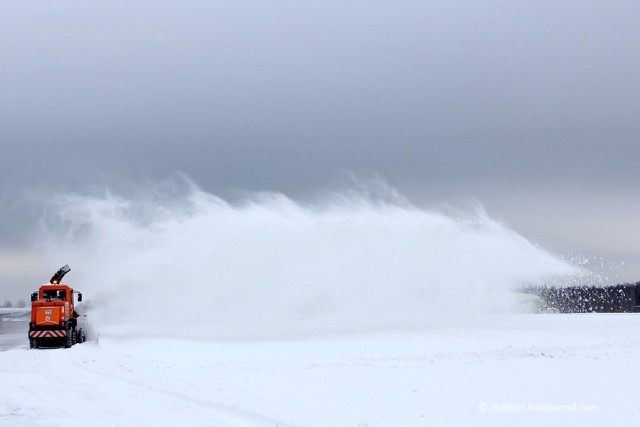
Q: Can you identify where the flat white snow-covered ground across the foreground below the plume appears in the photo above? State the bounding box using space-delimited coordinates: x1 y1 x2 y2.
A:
0 314 640 427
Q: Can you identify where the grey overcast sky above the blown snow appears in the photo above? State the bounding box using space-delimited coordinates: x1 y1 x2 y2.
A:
0 0 640 298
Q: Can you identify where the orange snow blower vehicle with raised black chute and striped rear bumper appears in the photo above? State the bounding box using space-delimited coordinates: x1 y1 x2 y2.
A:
29 265 86 348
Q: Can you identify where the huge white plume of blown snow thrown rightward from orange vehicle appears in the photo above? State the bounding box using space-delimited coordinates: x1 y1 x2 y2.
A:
33 179 576 338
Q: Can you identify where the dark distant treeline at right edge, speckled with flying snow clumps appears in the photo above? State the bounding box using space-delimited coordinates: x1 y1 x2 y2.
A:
523 282 640 313
